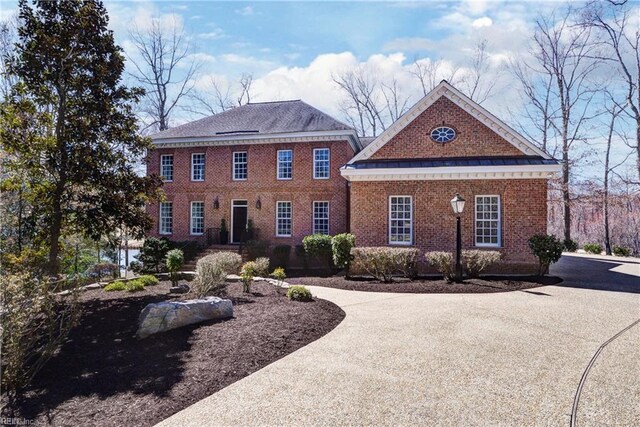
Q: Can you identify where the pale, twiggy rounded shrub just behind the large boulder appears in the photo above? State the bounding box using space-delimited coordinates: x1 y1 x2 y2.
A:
192 252 242 298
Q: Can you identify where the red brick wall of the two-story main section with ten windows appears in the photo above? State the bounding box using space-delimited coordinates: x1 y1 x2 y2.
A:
147 141 354 245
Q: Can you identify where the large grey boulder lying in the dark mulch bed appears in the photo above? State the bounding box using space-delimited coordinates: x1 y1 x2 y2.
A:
136 297 233 338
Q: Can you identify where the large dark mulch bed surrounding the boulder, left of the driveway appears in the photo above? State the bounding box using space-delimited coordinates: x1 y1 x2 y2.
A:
3 282 345 426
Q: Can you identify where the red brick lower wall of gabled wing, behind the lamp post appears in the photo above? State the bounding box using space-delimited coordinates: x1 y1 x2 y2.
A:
351 179 547 272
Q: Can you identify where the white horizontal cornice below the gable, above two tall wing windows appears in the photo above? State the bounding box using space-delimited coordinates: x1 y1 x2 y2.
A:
340 165 561 181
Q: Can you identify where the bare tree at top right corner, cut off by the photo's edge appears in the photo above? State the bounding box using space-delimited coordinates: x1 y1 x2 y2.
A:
582 1 640 182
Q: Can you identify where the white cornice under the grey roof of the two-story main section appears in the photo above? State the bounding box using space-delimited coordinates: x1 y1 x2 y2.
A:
153 130 361 152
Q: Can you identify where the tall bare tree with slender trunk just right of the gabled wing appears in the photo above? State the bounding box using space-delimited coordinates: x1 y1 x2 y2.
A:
533 8 600 244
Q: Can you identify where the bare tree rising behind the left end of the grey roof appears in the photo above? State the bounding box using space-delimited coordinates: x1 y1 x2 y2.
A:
128 18 197 131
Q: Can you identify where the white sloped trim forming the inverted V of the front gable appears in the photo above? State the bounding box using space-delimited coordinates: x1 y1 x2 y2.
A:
349 80 551 164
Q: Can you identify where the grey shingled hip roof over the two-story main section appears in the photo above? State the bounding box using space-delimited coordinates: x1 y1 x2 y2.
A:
151 100 352 141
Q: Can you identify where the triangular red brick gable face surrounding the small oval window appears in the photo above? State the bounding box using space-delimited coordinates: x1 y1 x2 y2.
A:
371 97 523 159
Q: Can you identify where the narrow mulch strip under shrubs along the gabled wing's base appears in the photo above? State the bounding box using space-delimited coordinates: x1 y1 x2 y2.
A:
287 276 562 294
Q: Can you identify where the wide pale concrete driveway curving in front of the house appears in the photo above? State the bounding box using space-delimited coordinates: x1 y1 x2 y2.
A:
156 255 640 426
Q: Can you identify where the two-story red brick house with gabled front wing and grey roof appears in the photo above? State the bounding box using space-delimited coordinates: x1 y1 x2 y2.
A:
147 81 559 272
